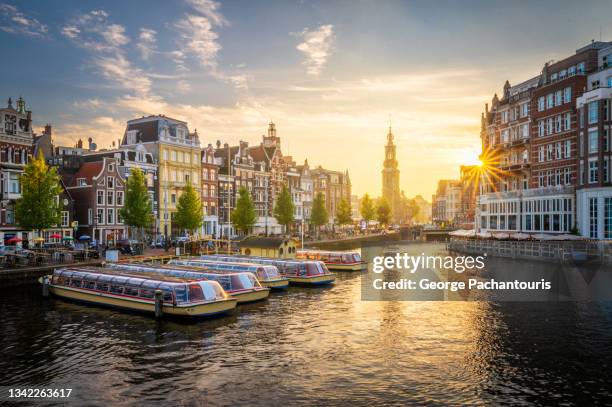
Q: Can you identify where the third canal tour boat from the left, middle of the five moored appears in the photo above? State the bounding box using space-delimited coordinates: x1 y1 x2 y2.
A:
168 257 289 290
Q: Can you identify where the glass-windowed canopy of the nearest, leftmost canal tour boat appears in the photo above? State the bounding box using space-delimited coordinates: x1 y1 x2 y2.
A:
51 267 227 304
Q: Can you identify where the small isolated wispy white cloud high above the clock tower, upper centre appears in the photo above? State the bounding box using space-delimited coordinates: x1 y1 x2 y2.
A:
294 24 334 76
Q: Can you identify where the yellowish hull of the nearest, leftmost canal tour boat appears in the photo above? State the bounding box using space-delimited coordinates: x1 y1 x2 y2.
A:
49 286 237 318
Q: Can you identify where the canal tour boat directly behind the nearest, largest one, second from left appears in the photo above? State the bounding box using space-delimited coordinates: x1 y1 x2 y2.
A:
106 263 270 304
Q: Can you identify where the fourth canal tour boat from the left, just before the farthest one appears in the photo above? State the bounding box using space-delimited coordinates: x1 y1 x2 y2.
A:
200 254 336 285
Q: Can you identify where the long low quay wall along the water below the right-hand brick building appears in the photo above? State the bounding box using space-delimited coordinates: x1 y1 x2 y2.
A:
448 239 612 265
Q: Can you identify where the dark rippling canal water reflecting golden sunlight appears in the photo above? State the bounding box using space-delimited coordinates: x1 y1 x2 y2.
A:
0 244 612 405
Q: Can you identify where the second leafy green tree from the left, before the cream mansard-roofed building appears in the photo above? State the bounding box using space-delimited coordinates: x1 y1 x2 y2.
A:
120 168 153 238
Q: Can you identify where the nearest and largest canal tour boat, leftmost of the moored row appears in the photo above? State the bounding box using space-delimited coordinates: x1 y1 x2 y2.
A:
42 267 237 317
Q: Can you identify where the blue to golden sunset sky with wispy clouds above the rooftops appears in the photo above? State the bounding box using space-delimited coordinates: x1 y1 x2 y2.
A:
0 0 612 199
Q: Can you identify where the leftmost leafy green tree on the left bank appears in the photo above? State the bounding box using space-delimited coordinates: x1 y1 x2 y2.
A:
15 152 62 236
